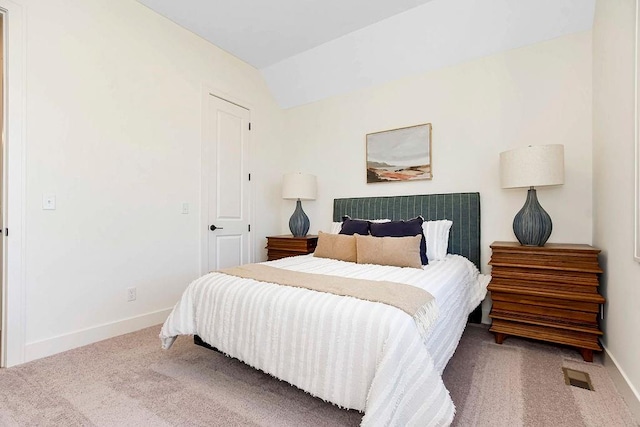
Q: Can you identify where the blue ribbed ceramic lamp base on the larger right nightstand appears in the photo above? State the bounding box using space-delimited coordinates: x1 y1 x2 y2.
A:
513 187 553 246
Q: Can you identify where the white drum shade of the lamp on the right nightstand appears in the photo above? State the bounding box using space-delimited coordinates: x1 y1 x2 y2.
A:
500 144 564 188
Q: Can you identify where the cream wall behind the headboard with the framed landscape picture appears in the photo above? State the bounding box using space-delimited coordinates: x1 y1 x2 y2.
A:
282 32 592 270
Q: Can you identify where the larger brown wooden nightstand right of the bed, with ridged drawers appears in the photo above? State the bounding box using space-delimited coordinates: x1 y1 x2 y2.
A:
488 242 605 362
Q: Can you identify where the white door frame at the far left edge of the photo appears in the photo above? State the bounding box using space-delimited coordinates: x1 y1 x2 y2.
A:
0 0 27 367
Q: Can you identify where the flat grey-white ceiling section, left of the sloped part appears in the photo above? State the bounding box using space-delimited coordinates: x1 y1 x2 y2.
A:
139 0 438 69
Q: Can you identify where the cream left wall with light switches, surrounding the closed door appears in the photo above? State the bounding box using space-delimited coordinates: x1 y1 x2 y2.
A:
21 0 282 360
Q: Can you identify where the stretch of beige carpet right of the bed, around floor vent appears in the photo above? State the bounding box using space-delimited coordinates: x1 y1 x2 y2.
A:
443 325 637 427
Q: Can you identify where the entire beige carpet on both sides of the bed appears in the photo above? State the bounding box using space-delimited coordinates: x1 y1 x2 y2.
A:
0 326 636 426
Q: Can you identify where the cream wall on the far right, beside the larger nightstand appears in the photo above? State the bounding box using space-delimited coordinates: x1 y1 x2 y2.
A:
593 0 640 416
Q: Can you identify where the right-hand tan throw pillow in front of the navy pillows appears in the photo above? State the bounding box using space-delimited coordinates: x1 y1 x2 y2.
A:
355 234 422 268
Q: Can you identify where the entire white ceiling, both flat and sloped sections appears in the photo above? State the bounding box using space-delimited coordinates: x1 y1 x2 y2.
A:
138 0 595 108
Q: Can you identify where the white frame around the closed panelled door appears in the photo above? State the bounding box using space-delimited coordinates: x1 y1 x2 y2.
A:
199 83 256 275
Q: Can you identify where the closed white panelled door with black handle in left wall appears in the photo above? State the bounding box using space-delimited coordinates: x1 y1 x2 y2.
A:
203 94 251 272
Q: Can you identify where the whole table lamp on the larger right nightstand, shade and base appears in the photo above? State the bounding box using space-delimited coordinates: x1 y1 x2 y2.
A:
500 144 564 246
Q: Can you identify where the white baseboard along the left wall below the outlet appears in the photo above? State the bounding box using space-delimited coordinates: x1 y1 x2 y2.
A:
25 308 171 362
